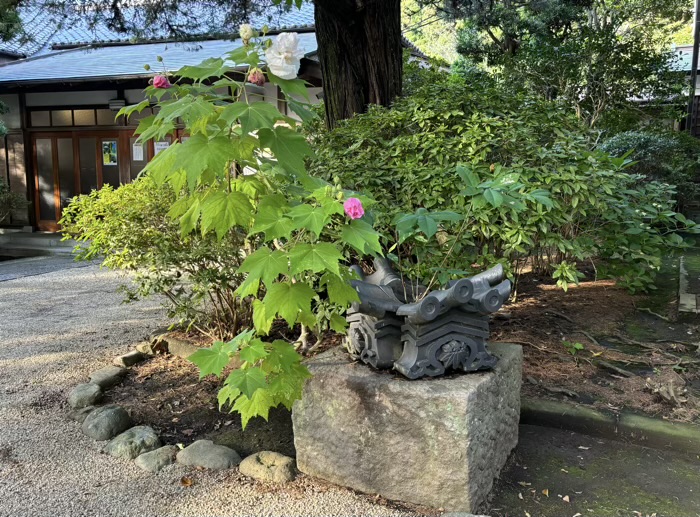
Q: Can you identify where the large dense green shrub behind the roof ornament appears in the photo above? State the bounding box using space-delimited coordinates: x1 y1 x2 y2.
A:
309 66 686 289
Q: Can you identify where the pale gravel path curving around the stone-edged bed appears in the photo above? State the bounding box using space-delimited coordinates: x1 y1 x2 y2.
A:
0 259 422 517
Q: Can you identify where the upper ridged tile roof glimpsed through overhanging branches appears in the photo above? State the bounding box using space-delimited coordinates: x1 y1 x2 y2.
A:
0 0 314 57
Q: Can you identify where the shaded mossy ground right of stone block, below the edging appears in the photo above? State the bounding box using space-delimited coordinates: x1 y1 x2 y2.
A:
487 425 700 517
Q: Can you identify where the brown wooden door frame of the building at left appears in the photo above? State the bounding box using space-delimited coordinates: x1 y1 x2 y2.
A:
30 128 135 232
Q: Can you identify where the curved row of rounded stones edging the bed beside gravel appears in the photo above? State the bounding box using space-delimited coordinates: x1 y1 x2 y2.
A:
67 331 298 484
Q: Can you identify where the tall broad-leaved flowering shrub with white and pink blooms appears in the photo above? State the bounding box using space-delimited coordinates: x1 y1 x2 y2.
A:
120 27 381 426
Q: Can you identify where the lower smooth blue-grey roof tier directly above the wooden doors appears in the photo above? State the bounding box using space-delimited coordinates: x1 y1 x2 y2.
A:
0 32 316 87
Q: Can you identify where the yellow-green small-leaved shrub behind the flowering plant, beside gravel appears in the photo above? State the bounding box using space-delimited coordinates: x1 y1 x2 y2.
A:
61 177 251 338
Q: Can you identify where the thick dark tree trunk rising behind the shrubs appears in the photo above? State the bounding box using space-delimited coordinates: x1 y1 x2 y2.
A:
315 0 403 129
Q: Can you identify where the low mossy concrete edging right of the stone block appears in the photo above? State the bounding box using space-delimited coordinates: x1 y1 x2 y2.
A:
520 397 700 454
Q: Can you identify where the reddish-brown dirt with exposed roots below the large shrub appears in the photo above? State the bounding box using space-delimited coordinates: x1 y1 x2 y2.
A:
491 270 700 422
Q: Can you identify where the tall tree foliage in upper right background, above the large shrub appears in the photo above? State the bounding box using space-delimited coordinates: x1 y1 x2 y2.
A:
452 0 692 128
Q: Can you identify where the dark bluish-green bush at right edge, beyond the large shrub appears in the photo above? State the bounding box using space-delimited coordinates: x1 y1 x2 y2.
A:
600 130 700 211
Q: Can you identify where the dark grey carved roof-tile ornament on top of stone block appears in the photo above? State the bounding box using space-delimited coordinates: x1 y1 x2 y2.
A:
345 259 511 379
